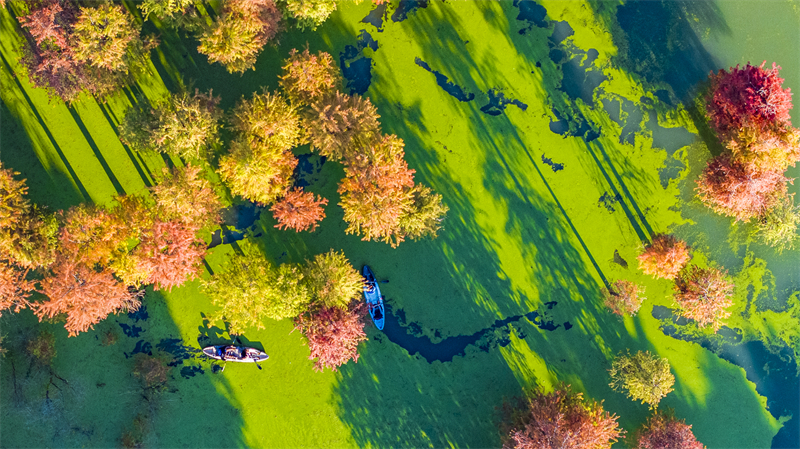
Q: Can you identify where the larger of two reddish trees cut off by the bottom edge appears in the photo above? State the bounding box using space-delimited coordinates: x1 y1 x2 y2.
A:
503 386 624 449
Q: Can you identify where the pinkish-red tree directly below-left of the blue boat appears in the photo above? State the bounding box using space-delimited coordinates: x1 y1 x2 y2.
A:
295 302 367 371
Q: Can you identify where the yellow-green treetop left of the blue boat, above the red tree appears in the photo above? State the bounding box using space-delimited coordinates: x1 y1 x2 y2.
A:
303 249 364 309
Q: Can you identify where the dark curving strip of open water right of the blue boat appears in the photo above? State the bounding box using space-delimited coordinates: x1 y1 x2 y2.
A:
383 301 572 363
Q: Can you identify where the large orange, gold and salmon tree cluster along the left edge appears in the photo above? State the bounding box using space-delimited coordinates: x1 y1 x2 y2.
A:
0 166 220 336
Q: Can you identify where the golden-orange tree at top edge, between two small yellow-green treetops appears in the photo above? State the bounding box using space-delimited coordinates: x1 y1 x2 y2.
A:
197 0 282 73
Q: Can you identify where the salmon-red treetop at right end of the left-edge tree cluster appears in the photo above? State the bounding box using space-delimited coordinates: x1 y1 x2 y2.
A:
133 220 206 290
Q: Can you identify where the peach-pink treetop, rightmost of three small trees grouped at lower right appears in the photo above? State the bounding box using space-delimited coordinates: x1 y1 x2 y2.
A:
675 265 734 332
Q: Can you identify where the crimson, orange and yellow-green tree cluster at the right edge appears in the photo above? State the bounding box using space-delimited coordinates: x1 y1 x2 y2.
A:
696 61 800 251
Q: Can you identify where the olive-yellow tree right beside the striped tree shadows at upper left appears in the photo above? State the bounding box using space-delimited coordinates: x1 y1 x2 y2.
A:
119 89 222 160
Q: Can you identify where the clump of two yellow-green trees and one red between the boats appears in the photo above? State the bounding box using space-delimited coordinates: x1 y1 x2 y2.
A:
203 244 367 371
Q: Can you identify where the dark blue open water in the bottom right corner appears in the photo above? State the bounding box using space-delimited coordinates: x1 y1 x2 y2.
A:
652 306 800 449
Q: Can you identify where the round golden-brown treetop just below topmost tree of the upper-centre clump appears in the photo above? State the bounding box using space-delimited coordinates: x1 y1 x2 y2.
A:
305 92 380 161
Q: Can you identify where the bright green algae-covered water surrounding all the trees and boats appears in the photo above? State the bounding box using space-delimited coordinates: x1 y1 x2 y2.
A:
0 0 800 448
